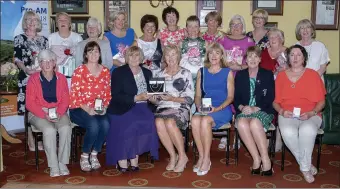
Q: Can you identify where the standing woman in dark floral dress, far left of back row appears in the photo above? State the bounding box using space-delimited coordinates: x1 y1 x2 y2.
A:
14 11 48 151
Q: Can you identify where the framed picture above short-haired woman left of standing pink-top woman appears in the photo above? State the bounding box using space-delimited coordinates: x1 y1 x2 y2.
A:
196 0 223 27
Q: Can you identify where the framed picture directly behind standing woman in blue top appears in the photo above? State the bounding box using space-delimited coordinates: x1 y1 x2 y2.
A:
104 0 130 30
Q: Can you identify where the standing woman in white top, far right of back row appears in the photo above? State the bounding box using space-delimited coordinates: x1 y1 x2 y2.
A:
295 19 330 78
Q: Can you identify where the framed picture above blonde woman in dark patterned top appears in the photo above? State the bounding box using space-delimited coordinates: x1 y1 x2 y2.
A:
251 0 283 15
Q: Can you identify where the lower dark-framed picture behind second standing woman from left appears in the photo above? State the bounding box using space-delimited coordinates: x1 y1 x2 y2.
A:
50 16 89 40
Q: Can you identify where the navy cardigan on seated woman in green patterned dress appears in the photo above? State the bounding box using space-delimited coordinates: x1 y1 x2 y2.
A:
234 67 275 115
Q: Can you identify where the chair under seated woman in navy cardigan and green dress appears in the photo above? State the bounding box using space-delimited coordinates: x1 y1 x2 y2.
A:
235 124 276 166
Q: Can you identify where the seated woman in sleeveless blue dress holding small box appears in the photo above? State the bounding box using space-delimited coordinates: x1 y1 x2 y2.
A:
191 43 234 176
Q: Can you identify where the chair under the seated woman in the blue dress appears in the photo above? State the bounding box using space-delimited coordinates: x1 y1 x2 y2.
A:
193 123 231 166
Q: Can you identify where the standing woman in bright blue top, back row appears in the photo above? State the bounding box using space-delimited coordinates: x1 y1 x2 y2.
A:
103 12 137 71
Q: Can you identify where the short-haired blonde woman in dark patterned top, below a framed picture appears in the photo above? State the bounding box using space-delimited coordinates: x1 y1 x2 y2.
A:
247 9 268 50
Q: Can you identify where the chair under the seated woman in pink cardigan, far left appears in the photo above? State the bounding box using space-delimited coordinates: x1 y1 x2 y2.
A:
24 110 43 171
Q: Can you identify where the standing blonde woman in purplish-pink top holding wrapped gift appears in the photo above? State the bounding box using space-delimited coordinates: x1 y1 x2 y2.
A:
220 15 255 72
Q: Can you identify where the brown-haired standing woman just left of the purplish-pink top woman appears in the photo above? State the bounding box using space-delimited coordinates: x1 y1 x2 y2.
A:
202 11 226 44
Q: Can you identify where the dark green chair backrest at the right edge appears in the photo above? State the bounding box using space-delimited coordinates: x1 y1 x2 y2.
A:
324 73 340 105
